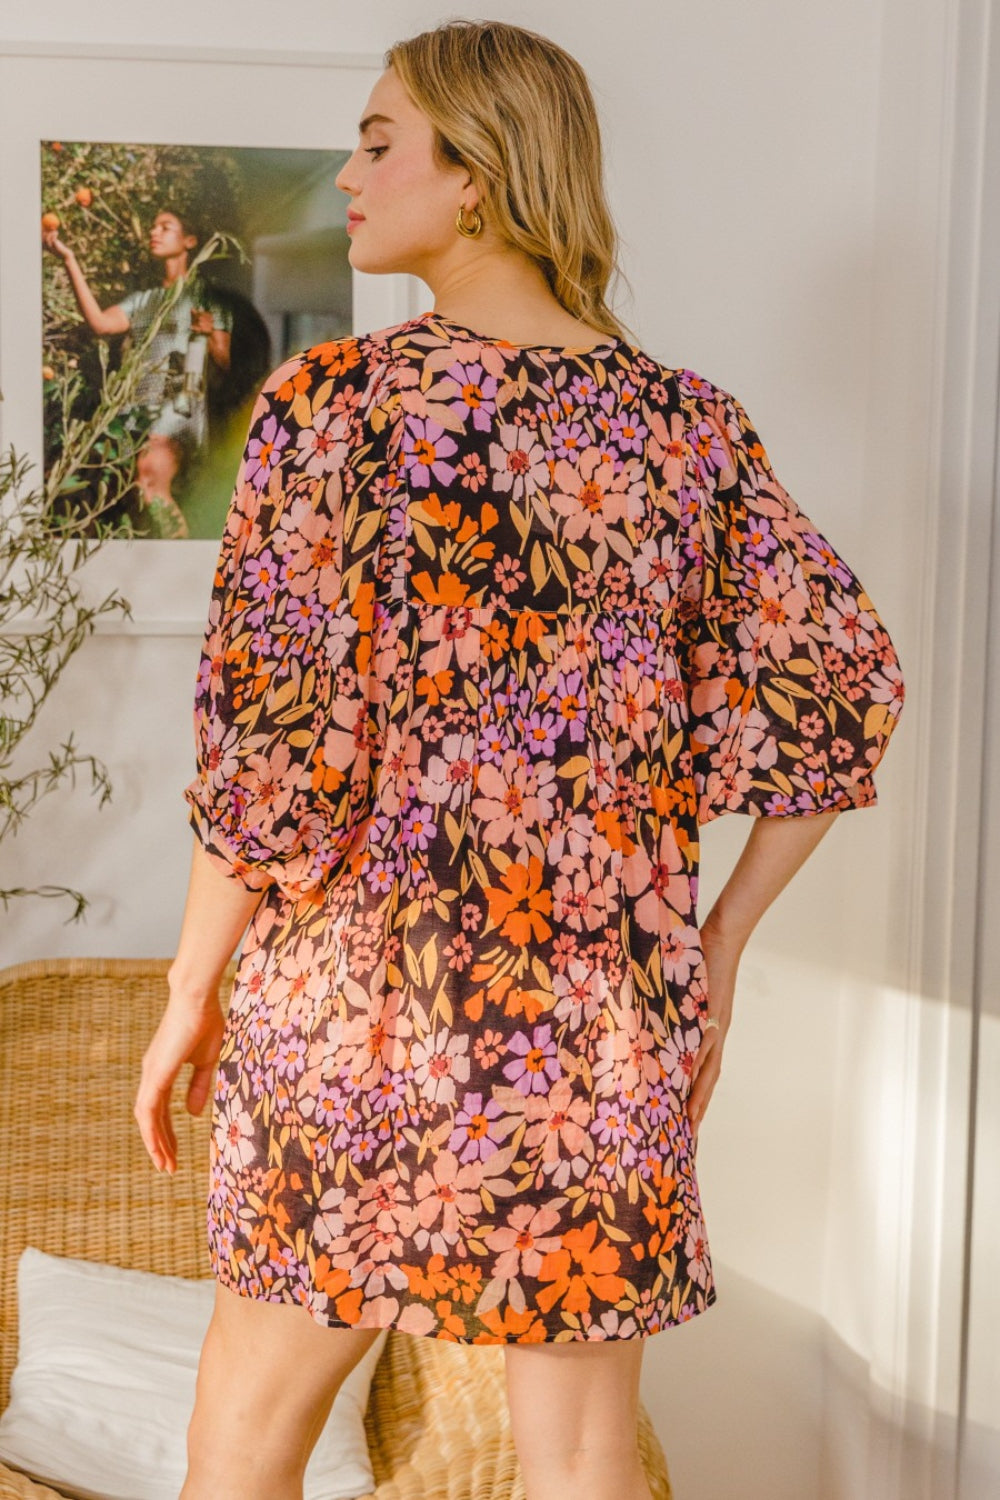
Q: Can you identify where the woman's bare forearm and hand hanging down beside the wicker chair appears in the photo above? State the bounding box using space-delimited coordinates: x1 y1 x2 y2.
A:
133 842 262 1173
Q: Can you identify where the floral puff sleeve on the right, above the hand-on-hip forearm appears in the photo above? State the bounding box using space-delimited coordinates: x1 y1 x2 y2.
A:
679 372 904 824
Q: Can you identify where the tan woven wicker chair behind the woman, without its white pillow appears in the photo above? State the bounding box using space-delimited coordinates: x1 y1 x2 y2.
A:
0 959 670 1500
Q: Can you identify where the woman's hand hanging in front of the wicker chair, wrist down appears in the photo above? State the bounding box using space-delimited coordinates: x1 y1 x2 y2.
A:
133 990 225 1173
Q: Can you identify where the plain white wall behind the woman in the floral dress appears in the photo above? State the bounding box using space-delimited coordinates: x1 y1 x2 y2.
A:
0 0 971 1500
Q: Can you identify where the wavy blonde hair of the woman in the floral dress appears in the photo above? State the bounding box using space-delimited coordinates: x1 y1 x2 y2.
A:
385 21 625 338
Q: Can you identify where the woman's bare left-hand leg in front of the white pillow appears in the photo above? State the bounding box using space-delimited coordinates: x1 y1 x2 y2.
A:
180 1283 378 1500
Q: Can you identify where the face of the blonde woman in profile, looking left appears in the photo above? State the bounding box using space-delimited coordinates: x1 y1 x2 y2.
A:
337 68 477 285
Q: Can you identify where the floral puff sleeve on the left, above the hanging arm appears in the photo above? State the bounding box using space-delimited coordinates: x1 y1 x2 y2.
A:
184 341 386 899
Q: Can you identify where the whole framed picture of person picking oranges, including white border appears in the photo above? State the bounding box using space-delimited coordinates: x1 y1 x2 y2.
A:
0 47 430 621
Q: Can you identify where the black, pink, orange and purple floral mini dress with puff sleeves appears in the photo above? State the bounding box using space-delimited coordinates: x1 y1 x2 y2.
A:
186 314 904 1343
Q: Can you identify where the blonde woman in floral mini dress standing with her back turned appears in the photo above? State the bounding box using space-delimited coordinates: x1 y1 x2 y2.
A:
136 23 903 1500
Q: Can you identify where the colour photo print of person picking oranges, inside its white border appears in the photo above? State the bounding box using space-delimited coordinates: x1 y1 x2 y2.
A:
40 141 352 539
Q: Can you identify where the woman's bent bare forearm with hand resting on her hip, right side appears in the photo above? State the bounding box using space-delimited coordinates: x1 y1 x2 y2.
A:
688 810 840 1136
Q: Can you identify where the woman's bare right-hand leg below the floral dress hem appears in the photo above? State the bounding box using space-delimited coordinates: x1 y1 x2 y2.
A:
504 1338 651 1500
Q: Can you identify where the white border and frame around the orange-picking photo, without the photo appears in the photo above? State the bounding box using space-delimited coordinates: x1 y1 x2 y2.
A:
0 44 430 635
